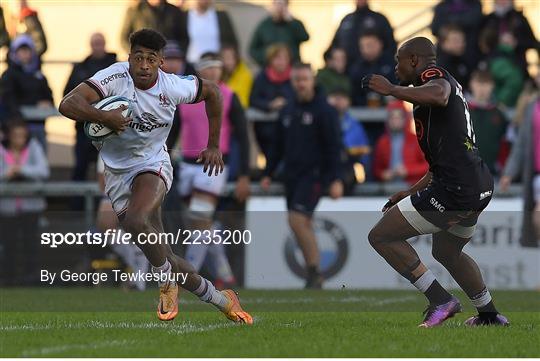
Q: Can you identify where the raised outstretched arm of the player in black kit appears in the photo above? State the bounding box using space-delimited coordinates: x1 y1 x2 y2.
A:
362 74 451 107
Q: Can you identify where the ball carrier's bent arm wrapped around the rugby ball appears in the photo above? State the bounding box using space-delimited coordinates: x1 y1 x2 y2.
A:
58 83 130 132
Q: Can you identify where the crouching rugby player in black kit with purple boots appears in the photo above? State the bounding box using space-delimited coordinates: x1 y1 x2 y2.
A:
362 37 509 327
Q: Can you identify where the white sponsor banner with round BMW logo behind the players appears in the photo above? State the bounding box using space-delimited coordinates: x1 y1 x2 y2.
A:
245 197 540 289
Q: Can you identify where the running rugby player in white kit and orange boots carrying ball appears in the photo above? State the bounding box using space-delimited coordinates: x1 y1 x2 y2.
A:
59 29 253 324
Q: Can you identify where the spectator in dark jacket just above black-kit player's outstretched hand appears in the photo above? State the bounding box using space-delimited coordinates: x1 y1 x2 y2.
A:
349 31 396 107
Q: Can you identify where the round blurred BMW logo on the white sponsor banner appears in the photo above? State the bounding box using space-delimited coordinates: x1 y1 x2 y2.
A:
284 218 349 279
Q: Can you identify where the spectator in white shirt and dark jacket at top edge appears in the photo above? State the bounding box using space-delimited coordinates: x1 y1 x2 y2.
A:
187 0 238 63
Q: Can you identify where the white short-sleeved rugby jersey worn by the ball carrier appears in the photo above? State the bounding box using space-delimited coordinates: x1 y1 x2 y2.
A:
85 62 199 170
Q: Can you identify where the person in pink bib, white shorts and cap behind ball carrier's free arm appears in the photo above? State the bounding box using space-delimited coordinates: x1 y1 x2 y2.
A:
167 52 249 286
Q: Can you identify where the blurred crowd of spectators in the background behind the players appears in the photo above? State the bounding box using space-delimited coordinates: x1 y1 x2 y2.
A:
0 0 540 286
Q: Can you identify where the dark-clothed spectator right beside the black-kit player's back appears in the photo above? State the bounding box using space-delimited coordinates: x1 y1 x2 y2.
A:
469 70 508 175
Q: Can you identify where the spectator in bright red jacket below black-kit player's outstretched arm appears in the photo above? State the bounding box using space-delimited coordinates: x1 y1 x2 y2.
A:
373 100 429 185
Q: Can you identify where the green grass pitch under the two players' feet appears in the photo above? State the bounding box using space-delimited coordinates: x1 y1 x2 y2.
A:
0 288 540 357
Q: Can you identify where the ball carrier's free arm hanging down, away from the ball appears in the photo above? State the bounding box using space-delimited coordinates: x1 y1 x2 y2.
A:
198 79 225 176
